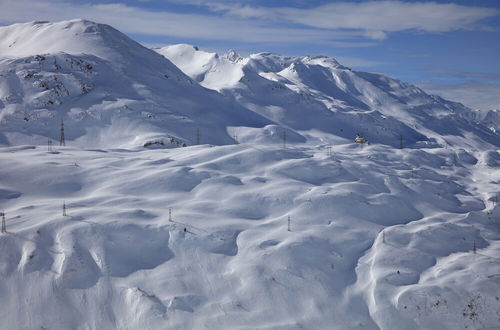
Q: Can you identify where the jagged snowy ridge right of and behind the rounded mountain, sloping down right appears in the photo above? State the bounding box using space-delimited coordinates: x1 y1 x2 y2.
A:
157 45 498 146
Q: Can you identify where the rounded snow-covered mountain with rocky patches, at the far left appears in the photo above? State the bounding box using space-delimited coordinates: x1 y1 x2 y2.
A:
0 20 270 147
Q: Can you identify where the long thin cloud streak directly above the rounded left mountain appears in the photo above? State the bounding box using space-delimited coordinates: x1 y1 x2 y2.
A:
0 0 374 47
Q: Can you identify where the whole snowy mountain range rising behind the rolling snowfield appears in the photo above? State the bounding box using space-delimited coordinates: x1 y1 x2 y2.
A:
0 20 498 147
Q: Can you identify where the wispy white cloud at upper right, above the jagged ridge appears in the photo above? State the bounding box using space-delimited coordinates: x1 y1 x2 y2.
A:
205 1 499 39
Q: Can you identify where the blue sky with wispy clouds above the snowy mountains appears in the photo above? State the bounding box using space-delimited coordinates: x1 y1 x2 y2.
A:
0 0 500 109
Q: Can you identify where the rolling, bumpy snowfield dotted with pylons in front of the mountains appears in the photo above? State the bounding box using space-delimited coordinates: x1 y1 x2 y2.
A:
0 143 500 329
